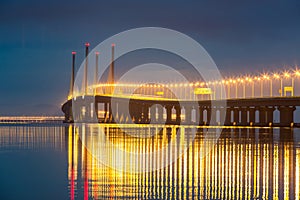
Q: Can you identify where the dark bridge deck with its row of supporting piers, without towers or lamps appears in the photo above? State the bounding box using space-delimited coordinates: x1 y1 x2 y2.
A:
62 95 300 127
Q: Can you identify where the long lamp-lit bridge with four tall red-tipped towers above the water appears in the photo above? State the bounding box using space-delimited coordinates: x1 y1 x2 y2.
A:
62 43 300 127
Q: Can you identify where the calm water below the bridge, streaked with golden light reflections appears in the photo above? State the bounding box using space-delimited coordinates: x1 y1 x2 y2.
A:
0 123 300 200
